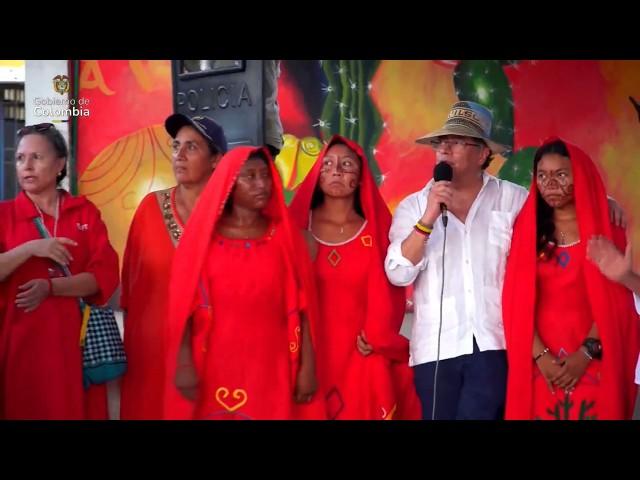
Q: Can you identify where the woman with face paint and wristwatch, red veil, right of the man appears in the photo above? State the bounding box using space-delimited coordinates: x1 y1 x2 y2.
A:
503 138 640 420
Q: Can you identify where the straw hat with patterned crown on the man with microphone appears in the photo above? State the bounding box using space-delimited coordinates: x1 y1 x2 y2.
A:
416 102 510 153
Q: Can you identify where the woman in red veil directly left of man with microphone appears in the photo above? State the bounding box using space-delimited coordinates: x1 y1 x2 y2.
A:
290 135 421 420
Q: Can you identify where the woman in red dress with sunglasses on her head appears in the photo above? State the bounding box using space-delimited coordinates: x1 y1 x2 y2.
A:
0 123 118 420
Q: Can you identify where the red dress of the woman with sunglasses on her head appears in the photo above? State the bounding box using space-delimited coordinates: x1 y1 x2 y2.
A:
0 192 118 419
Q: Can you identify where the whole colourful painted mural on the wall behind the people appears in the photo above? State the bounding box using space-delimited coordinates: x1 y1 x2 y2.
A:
78 60 640 267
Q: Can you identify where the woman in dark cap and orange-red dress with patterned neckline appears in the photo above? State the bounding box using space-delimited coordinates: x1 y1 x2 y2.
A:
120 113 227 420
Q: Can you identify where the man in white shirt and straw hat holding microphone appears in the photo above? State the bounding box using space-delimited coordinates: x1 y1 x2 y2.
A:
385 101 624 420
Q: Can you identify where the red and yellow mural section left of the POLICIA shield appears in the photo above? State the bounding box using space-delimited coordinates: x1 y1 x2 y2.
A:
77 60 175 262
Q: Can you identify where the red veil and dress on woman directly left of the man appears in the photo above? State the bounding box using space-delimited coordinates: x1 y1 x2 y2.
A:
290 135 421 419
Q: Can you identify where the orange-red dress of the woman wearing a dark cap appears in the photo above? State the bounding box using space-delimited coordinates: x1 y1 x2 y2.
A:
120 192 175 420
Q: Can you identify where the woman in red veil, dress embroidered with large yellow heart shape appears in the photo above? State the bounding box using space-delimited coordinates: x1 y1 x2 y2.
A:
165 147 316 420
